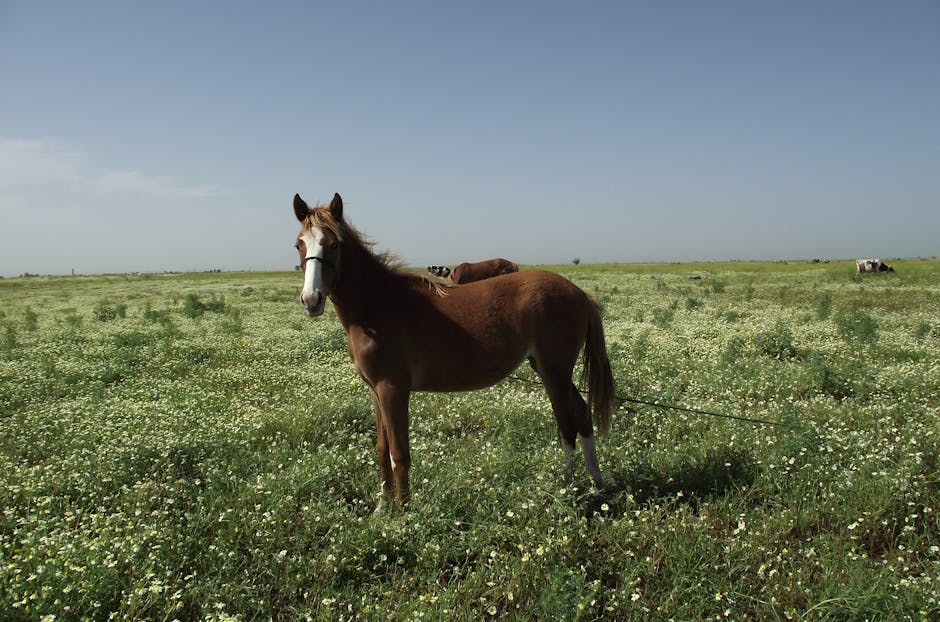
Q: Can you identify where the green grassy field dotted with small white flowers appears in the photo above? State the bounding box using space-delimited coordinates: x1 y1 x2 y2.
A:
0 260 940 620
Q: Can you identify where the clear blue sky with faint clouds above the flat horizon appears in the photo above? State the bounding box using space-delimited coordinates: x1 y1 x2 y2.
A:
0 0 940 276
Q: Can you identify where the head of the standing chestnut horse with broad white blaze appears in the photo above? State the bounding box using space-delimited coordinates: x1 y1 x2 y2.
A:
294 194 343 315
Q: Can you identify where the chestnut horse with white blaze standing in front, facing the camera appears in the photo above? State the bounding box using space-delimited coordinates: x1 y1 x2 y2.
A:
294 194 614 510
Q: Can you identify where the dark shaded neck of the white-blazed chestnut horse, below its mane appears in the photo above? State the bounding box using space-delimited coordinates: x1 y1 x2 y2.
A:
330 246 398 330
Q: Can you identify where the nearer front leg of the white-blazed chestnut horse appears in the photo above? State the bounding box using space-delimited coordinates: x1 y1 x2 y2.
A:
374 381 411 507
